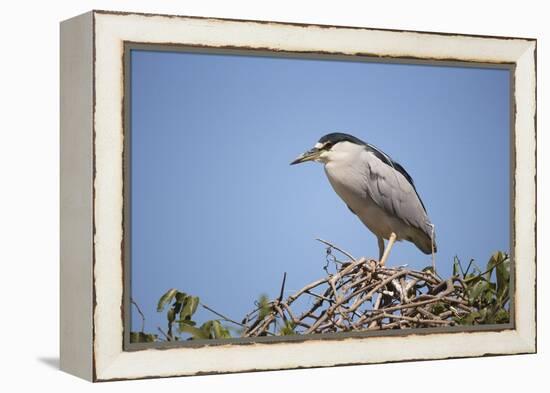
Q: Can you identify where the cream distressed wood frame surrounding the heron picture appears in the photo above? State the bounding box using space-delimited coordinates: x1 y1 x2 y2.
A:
60 11 536 381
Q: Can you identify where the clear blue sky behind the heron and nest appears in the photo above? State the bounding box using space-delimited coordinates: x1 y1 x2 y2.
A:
131 50 510 332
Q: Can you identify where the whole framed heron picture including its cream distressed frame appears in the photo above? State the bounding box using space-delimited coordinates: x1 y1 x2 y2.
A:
60 11 536 381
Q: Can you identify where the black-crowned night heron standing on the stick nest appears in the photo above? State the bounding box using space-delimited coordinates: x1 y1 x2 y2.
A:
291 133 437 265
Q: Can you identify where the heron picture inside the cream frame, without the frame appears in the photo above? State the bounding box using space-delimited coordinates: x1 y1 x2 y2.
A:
125 45 513 345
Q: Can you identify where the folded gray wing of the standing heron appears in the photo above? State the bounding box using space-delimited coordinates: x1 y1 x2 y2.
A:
364 150 430 231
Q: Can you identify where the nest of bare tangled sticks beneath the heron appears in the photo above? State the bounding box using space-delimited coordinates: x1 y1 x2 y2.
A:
242 241 472 337
